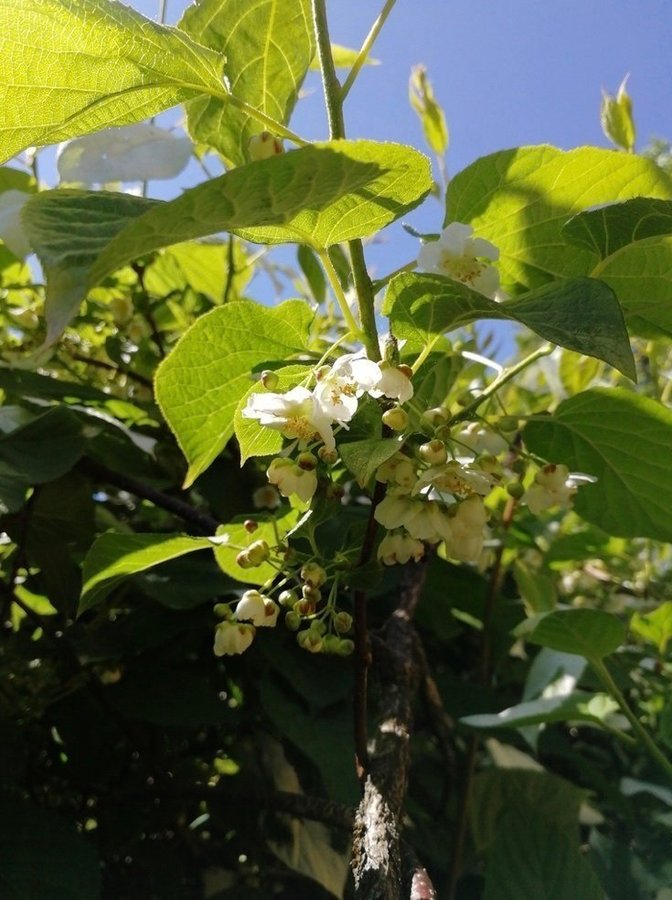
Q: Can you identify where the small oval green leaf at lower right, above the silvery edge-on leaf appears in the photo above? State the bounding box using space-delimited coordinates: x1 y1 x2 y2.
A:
518 609 625 660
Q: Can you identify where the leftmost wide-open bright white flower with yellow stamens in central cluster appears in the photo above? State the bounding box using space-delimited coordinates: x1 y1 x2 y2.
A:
242 387 336 450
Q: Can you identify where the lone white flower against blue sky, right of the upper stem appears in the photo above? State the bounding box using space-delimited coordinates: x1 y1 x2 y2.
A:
418 222 499 298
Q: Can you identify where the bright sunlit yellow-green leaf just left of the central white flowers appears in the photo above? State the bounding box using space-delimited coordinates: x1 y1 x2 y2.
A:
155 300 313 486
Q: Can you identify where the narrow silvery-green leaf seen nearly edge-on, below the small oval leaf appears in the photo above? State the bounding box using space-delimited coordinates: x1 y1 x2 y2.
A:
460 691 619 730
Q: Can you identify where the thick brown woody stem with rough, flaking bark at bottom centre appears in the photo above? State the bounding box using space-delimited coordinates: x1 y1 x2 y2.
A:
352 563 426 900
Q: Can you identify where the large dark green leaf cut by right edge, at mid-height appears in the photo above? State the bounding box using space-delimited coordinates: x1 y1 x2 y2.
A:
523 388 672 541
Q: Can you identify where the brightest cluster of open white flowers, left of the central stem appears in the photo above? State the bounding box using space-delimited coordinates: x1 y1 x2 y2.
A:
242 351 413 502
